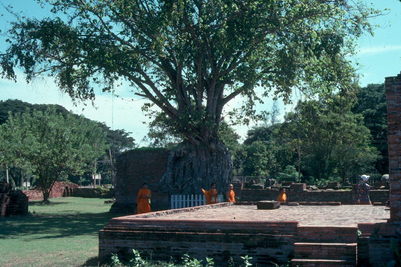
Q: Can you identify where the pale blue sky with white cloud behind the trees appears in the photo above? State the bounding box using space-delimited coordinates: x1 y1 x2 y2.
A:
0 0 401 145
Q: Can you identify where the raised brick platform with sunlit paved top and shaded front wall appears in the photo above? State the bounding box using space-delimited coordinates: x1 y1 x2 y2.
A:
99 203 389 266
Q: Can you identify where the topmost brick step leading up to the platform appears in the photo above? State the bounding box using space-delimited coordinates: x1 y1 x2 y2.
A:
297 226 358 243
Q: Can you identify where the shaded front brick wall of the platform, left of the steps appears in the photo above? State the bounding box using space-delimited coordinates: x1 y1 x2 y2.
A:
99 206 298 266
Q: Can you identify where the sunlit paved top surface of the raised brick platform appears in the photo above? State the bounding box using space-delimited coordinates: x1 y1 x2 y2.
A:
135 205 390 226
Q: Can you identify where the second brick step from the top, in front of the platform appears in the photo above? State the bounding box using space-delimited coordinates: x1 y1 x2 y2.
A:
294 243 357 264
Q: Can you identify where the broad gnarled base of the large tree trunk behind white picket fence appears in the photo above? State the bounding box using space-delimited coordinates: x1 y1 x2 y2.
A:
160 141 233 194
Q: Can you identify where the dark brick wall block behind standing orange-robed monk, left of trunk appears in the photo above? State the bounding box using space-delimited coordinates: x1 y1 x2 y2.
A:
111 149 169 213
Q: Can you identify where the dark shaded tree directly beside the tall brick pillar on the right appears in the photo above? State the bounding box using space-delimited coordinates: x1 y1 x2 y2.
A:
352 84 388 174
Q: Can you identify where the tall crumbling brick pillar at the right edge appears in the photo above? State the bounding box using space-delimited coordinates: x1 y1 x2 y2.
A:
385 73 401 222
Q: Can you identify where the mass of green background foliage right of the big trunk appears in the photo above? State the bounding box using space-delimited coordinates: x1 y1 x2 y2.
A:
236 94 379 184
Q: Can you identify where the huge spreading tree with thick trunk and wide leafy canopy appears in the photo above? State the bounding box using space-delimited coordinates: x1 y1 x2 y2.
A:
1 0 371 192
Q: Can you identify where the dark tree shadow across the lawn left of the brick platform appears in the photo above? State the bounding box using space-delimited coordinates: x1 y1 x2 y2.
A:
0 212 124 240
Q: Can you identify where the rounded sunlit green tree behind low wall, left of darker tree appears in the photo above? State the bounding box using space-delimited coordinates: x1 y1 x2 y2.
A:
281 96 377 182
